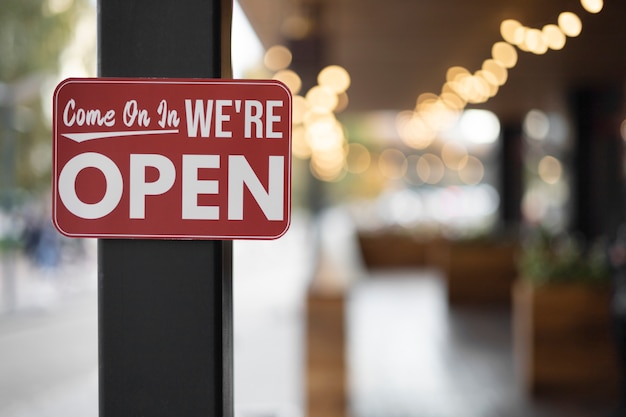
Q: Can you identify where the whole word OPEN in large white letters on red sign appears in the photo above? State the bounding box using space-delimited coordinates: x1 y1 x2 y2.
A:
58 152 285 220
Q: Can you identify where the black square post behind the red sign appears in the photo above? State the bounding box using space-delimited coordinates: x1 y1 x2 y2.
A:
98 0 233 417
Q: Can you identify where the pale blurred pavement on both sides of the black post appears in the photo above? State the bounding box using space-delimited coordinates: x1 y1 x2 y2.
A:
0 213 313 417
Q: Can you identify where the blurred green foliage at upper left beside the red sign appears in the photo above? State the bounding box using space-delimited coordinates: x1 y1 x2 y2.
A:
0 0 88 193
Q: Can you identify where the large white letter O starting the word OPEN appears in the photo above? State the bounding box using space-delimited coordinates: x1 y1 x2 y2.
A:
58 152 124 219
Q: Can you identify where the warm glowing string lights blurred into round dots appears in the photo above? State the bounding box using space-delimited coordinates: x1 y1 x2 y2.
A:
264 0 596 184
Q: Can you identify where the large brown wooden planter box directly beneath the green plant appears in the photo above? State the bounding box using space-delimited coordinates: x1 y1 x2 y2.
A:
513 280 618 398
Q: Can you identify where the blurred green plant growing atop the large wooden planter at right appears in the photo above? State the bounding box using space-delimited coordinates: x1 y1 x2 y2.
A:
518 232 609 285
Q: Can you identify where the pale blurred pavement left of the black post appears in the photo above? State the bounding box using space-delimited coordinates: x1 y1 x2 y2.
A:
0 240 98 417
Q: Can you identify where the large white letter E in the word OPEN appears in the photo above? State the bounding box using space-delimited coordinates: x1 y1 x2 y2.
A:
182 155 220 220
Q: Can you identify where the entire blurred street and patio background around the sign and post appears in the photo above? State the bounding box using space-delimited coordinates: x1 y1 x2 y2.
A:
0 0 626 417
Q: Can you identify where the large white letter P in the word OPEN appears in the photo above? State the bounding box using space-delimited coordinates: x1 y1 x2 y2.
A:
130 154 176 219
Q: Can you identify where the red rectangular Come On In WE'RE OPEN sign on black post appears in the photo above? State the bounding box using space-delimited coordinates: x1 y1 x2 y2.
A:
52 78 292 239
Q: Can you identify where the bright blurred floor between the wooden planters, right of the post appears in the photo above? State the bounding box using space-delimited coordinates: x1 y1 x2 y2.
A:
348 271 609 417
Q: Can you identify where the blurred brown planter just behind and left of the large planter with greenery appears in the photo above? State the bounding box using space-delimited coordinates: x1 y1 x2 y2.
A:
438 242 518 306
